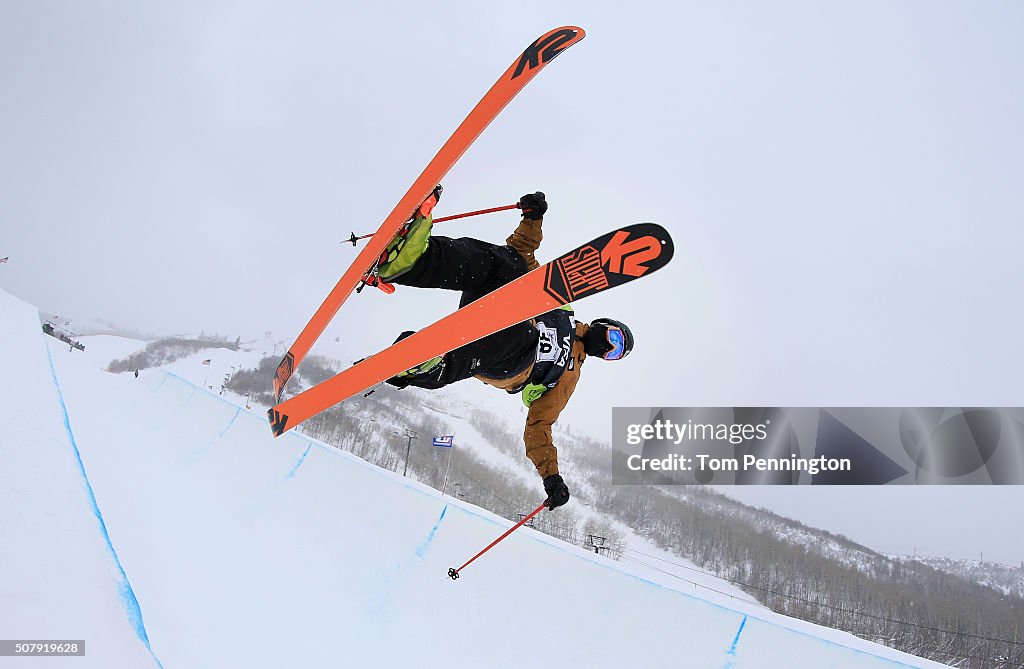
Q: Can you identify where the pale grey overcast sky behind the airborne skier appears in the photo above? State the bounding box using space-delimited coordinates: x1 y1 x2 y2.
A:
0 0 1024 561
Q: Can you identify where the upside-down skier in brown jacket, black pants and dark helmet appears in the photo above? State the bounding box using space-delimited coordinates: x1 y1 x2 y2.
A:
378 185 633 509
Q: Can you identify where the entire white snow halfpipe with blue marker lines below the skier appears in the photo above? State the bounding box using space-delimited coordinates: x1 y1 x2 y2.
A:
0 288 940 669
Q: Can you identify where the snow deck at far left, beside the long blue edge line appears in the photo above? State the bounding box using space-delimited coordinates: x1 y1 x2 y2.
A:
0 291 159 667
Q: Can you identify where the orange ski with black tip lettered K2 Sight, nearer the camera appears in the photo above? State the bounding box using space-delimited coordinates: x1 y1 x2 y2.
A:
267 223 674 436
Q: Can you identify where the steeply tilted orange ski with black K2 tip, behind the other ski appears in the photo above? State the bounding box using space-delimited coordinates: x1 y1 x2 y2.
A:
273 26 586 402
